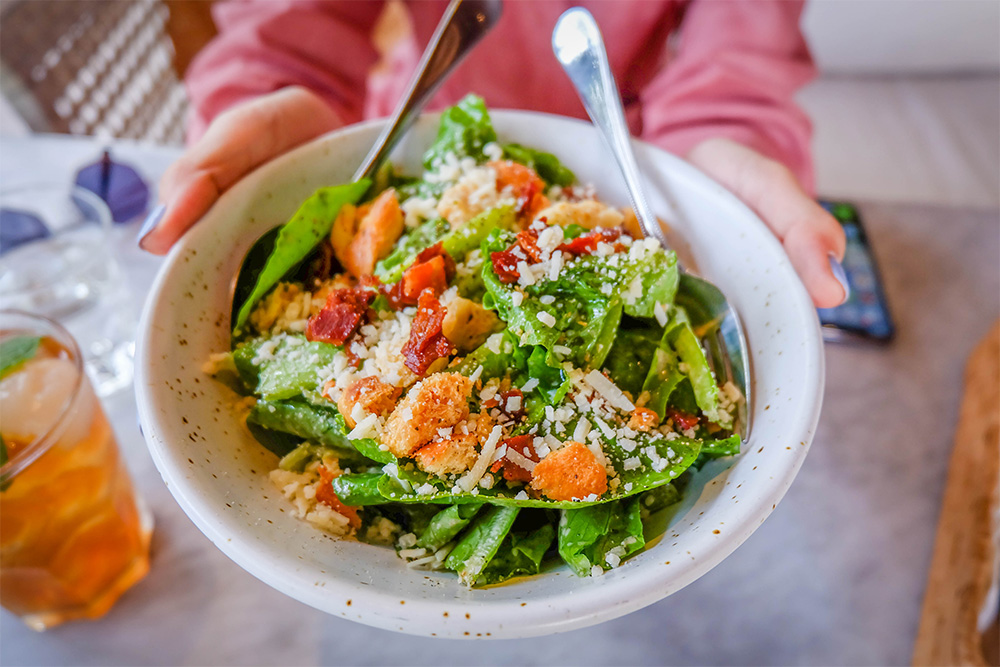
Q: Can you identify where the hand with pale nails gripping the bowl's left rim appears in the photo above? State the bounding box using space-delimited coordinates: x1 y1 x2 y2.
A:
139 86 341 255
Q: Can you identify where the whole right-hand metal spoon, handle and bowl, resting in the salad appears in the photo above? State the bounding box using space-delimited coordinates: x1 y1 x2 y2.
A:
552 7 751 441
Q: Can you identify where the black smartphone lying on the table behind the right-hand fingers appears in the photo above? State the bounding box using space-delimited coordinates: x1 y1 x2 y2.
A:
818 200 895 343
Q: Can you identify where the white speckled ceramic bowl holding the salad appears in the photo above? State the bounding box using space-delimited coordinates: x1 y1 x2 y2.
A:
136 111 823 638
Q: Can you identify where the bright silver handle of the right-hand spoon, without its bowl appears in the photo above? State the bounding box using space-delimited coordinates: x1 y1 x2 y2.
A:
552 7 667 247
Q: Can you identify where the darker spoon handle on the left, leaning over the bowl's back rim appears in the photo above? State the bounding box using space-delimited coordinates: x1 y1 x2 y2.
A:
354 0 502 181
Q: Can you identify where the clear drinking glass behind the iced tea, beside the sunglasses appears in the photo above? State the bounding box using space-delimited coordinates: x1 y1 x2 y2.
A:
0 183 136 396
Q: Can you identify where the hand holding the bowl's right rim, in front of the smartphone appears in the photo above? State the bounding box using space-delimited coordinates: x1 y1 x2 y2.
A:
687 139 847 308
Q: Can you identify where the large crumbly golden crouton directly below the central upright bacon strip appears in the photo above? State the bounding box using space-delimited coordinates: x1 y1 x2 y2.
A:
384 373 472 456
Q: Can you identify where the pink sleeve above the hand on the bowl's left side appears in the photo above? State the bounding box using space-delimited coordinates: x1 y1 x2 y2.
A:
185 0 383 141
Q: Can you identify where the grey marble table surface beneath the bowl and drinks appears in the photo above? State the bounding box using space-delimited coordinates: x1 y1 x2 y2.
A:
0 136 1000 665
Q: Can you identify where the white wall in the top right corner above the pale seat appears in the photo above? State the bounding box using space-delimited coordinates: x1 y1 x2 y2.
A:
803 0 1000 74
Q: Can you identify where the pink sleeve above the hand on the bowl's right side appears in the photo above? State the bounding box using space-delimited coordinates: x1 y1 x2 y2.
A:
642 0 815 192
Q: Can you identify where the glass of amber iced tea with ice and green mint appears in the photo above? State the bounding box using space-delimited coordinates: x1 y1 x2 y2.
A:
0 310 152 630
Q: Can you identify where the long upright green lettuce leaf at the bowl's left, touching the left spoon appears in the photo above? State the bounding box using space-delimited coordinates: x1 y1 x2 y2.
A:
233 179 371 334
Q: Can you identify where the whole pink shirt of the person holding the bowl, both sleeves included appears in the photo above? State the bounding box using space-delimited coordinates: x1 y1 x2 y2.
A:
186 0 815 190
